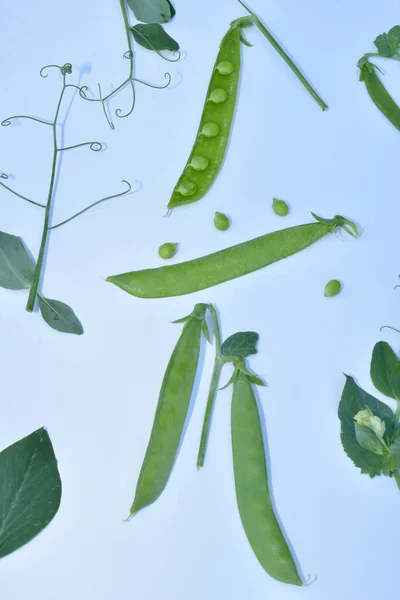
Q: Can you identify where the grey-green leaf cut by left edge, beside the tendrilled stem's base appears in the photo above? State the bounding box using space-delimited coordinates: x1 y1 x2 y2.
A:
0 231 35 290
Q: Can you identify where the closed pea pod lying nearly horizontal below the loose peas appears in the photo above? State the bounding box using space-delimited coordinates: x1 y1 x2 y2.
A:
106 215 359 298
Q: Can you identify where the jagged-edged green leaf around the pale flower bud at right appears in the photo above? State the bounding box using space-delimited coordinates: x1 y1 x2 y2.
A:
338 375 395 477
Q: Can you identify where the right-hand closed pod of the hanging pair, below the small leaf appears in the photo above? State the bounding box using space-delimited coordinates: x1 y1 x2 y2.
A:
231 371 302 585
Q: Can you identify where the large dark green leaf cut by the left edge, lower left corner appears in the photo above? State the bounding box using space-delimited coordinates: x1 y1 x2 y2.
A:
0 428 61 558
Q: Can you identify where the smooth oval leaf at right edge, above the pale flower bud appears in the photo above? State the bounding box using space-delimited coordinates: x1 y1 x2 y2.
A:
371 342 400 400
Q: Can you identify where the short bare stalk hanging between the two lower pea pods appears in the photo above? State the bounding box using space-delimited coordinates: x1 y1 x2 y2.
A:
197 304 225 469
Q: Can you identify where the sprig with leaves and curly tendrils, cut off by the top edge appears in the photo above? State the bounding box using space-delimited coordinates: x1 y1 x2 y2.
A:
80 0 181 129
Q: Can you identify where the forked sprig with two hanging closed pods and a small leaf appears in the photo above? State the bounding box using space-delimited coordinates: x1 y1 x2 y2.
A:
127 304 303 586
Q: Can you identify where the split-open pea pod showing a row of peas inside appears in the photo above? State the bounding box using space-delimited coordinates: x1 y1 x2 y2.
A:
168 27 240 210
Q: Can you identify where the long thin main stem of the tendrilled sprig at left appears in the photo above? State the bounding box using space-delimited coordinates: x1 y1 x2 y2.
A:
26 73 66 312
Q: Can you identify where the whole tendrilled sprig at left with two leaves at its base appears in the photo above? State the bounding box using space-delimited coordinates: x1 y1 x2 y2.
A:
0 63 132 334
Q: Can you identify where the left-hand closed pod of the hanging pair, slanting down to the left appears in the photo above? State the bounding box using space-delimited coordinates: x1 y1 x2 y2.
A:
130 304 207 516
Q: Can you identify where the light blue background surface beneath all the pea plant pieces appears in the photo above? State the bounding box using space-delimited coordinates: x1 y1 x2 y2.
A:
0 0 400 600
